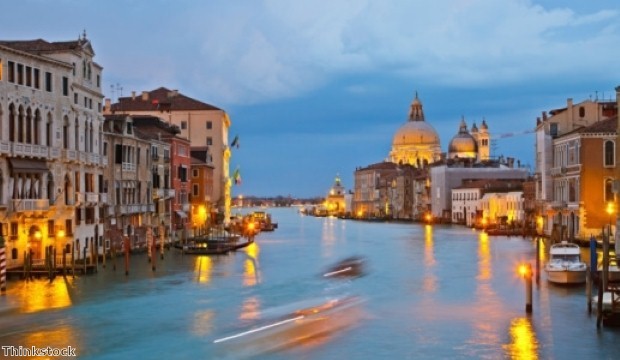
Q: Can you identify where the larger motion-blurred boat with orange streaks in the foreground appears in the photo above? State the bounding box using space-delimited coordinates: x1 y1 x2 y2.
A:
213 295 363 358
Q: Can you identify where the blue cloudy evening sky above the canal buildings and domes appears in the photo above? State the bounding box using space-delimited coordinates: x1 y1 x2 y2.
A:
0 0 620 197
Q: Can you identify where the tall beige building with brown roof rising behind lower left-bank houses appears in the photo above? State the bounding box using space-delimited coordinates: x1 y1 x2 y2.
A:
105 87 231 225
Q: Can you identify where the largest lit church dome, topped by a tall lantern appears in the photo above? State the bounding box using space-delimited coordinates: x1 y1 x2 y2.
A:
388 92 441 167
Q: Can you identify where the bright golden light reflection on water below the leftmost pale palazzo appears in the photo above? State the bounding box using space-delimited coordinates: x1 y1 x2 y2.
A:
9 278 72 313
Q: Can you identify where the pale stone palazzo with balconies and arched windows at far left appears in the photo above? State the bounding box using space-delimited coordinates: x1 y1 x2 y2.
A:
0 34 104 267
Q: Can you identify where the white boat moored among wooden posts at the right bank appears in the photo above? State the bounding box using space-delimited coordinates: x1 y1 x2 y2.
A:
545 241 587 284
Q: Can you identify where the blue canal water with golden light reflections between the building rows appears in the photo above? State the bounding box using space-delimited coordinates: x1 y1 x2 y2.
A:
0 208 620 359
